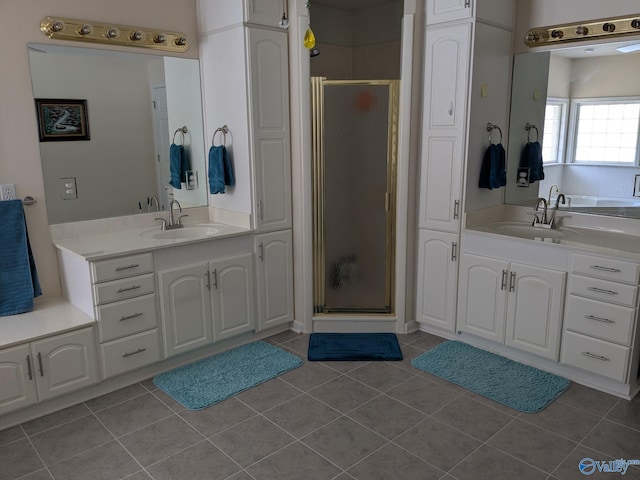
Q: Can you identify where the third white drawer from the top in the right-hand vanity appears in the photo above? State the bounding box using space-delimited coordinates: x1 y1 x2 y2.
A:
564 295 636 346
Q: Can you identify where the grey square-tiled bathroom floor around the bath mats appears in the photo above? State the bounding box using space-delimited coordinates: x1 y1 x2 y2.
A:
0 332 640 480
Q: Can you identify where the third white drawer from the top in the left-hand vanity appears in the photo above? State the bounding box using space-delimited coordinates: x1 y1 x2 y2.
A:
96 293 158 342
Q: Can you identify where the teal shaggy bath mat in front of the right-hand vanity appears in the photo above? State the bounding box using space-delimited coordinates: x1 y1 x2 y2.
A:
411 341 571 413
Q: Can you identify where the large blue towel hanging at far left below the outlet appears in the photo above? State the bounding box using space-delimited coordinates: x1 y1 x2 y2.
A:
0 200 42 316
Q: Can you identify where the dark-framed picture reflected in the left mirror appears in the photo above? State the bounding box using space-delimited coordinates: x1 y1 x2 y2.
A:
36 98 89 142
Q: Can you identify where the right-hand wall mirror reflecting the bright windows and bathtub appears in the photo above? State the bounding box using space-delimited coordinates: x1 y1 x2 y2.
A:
505 40 640 218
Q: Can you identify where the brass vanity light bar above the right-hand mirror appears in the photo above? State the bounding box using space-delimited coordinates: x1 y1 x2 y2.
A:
524 14 640 47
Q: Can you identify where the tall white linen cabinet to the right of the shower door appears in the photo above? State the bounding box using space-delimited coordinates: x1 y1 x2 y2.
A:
415 0 515 334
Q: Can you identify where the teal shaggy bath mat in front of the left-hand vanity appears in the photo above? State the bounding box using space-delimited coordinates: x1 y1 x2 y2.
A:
153 341 303 410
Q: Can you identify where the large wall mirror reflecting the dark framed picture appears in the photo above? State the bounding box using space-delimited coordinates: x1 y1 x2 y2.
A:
28 44 207 224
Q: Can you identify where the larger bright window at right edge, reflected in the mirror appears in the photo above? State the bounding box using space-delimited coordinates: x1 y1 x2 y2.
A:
571 97 640 165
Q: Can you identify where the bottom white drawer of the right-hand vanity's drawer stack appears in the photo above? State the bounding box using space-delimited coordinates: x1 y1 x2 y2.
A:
561 332 629 382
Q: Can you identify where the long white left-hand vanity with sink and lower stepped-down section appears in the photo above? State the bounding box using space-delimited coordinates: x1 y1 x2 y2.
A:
0 209 293 422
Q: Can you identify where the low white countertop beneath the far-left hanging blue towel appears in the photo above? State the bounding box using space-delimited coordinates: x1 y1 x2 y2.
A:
0 297 95 349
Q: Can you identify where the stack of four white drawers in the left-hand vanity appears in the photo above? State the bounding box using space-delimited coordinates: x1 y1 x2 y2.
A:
90 253 162 378
